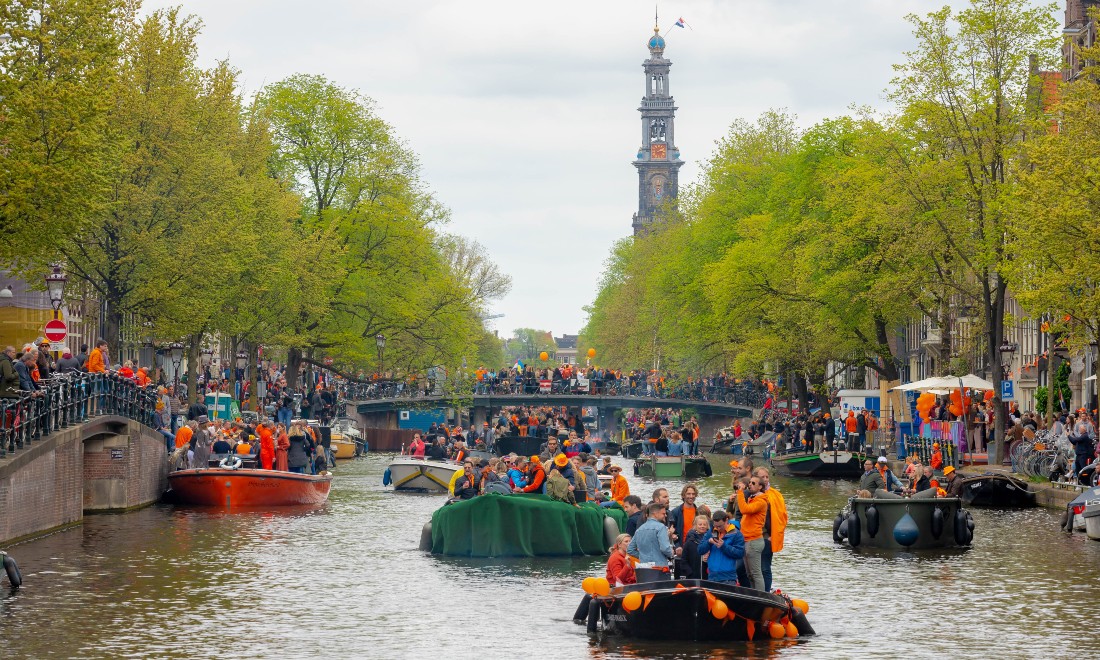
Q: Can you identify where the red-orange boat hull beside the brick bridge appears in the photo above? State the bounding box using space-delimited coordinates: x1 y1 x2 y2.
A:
168 468 332 508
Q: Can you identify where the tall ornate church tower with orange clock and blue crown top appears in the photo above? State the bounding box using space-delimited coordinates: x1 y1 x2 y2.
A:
634 25 683 235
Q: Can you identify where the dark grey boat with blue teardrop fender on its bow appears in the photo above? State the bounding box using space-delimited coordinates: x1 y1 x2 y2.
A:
833 491 974 550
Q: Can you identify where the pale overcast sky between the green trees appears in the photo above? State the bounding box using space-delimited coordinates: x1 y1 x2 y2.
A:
139 0 1038 336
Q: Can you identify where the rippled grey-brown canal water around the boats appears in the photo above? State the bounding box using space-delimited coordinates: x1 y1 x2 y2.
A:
0 455 1100 659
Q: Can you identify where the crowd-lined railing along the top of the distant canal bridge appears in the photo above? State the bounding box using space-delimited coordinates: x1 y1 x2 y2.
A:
341 380 768 408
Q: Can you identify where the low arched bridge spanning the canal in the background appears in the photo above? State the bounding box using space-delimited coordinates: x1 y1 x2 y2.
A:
348 394 760 440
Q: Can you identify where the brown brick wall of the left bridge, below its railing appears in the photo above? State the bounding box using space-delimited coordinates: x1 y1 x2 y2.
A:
0 416 168 542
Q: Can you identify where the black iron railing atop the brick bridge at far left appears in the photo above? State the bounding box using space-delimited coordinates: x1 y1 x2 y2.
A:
0 373 158 458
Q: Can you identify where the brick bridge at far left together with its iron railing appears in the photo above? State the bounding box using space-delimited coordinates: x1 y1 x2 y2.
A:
0 374 168 543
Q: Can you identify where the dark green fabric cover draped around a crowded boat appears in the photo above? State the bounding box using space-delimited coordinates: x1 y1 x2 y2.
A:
431 493 627 557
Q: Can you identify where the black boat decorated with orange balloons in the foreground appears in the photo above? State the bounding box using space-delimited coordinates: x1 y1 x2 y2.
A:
573 578 815 641
